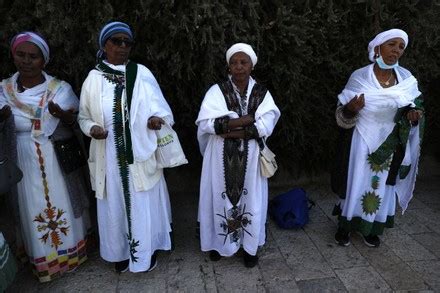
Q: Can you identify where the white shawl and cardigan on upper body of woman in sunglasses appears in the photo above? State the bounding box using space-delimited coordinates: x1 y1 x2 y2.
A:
78 63 174 199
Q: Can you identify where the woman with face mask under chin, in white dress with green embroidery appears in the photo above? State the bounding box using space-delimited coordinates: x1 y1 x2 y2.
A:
332 29 424 247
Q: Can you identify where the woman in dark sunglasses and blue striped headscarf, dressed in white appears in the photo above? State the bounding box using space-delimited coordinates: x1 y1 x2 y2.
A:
78 22 173 272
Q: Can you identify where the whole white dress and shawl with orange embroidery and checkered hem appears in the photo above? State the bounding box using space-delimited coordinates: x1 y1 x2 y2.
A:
0 73 90 282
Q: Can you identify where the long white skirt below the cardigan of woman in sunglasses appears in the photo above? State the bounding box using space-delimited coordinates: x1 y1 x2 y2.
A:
97 122 171 272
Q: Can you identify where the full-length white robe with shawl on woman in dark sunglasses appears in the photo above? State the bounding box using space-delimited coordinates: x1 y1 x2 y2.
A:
79 63 172 272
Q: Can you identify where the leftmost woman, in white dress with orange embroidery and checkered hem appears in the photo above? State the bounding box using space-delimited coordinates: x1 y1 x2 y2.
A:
0 32 89 282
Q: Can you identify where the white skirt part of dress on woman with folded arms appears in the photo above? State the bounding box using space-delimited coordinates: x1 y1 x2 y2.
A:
198 135 268 256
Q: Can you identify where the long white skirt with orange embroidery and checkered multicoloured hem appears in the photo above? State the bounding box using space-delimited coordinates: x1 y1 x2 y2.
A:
15 117 89 282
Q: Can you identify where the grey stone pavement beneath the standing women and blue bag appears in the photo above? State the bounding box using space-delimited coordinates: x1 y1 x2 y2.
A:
9 157 440 292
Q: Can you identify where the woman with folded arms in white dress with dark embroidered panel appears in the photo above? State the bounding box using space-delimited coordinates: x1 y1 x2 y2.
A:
196 43 280 267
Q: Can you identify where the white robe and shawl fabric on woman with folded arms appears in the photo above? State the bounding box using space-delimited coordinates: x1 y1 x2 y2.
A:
196 79 280 256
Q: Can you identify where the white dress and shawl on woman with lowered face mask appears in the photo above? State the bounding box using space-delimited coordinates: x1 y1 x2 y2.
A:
338 64 420 231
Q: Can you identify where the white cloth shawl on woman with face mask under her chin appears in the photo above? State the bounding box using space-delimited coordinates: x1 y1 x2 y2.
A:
338 64 421 153
